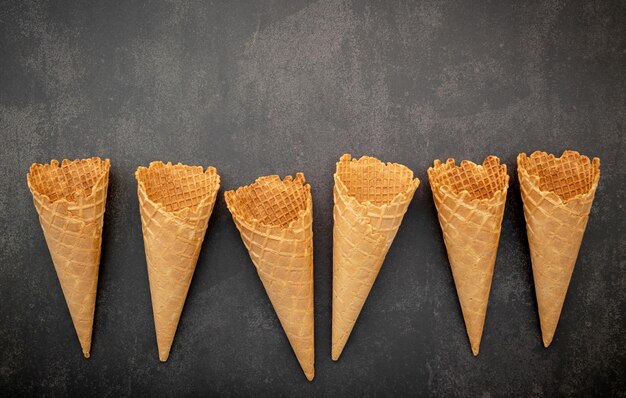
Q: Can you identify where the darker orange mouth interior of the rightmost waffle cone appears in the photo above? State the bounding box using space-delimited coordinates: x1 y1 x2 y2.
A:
519 151 600 202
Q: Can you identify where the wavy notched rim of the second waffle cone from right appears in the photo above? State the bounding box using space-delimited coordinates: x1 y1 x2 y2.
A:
427 155 510 206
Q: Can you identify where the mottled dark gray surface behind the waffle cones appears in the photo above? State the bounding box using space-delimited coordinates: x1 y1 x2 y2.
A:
0 0 626 397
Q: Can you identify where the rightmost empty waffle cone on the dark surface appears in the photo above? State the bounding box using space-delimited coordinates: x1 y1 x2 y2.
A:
517 151 600 347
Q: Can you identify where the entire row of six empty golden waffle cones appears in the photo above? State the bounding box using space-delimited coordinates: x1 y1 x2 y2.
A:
27 151 600 380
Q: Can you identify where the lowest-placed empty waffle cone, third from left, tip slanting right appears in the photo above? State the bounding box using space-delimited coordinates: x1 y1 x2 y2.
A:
225 173 315 380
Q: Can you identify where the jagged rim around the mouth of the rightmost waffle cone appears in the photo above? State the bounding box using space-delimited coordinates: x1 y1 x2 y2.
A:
517 149 600 205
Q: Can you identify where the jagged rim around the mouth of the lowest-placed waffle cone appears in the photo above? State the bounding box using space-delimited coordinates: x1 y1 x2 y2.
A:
224 172 313 231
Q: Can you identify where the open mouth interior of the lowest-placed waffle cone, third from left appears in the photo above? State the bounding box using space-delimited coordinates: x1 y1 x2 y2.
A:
227 174 310 228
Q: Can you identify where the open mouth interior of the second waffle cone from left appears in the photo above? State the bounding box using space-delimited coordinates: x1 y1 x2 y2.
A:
137 162 219 212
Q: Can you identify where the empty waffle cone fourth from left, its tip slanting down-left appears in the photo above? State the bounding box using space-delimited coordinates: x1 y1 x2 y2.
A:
331 155 419 361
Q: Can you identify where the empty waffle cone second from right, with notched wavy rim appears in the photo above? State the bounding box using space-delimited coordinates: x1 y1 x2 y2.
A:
428 156 509 355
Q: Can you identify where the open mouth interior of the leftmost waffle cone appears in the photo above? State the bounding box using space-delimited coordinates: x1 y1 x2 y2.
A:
28 157 109 203
